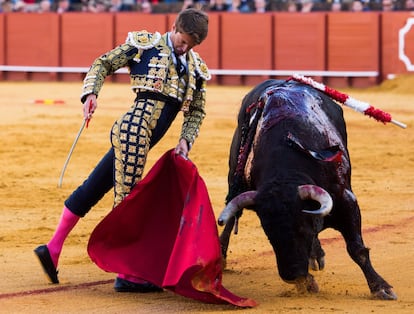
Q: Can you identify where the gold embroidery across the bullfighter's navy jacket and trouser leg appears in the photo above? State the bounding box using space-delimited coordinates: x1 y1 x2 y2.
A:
81 31 210 201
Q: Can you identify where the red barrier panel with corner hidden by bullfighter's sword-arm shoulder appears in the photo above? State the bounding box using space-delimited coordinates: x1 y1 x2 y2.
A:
61 13 114 81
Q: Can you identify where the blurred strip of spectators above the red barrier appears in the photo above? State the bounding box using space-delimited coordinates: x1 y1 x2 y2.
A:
0 0 414 14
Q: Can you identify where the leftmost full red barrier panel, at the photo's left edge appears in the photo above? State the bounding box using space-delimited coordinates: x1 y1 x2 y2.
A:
3 13 59 80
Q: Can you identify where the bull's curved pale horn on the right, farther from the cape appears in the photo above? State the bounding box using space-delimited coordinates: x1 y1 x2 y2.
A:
298 185 333 216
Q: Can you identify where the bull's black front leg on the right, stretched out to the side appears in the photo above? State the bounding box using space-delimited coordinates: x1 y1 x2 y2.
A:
337 190 397 300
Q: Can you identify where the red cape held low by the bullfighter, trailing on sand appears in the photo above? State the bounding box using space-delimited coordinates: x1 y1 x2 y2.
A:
88 150 256 307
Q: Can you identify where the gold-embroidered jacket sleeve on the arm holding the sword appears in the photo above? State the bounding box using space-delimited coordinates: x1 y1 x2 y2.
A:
81 43 138 102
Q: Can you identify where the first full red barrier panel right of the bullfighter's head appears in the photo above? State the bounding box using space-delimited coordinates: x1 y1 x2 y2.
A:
220 13 273 85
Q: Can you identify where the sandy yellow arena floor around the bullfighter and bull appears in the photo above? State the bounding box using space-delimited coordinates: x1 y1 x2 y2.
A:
0 76 414 313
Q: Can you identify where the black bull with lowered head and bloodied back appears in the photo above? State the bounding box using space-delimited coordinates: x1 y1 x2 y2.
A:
218 80 397 300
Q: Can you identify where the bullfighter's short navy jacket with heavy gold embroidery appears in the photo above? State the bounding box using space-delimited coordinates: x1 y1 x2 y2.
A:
81 31 211 147
